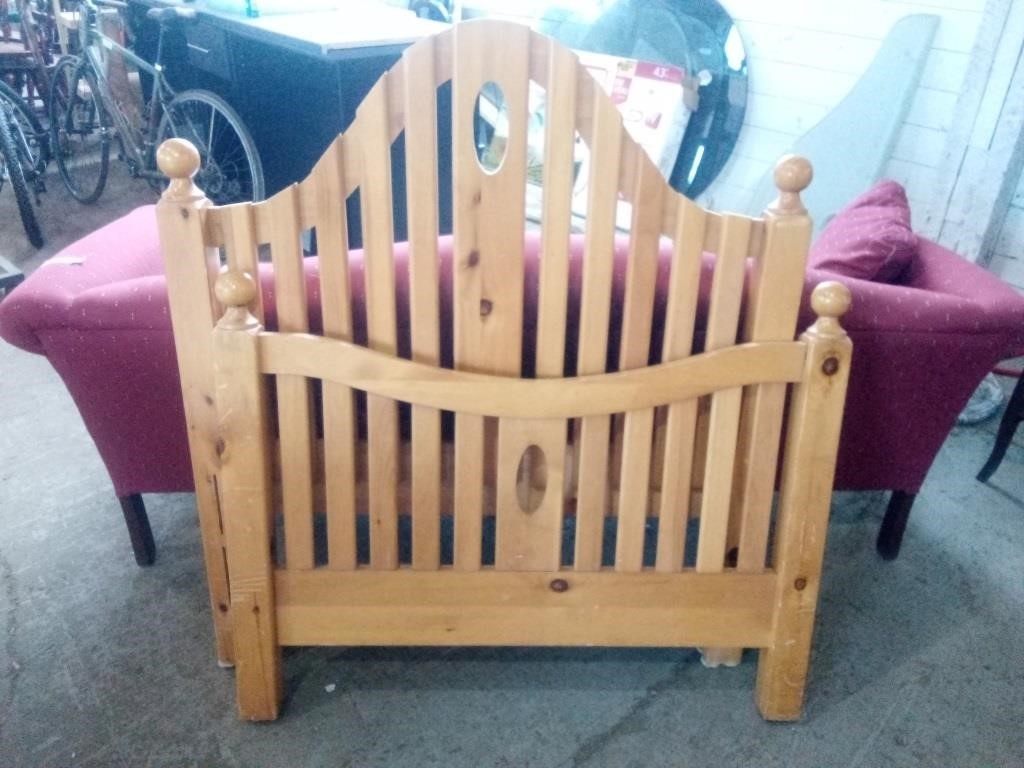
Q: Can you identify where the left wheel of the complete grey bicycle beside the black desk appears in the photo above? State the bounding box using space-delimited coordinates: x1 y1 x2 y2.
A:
49 56 111 203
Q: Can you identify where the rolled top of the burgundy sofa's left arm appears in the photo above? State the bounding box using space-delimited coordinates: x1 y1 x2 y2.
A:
0 205 160 354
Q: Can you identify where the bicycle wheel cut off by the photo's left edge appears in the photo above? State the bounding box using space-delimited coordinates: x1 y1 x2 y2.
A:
0 81 49 248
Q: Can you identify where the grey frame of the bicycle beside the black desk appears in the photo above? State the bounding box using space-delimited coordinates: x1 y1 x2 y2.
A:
80 0 175 179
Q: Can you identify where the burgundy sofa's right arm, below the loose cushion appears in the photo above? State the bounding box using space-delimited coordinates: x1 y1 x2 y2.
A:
801 240 1024 493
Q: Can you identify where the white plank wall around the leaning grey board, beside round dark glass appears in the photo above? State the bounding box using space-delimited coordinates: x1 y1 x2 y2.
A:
703 0 985 222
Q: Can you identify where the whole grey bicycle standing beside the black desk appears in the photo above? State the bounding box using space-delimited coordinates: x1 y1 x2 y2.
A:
49 0 264 205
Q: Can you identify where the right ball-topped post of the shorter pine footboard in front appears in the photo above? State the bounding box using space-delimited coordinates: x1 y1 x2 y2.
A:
757 281 852 720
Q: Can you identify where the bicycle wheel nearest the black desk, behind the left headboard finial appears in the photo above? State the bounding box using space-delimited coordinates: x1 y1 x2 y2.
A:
157 90 264 205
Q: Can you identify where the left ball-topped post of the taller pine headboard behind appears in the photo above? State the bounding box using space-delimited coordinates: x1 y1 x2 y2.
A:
157 138 234 667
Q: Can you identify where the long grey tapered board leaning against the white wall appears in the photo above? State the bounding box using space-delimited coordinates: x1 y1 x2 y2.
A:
746 13 939 234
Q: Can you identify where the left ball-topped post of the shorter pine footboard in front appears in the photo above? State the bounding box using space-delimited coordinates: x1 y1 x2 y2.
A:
213 271 283 720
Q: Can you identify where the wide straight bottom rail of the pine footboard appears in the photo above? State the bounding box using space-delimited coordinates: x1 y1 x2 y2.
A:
274 568 775 647
